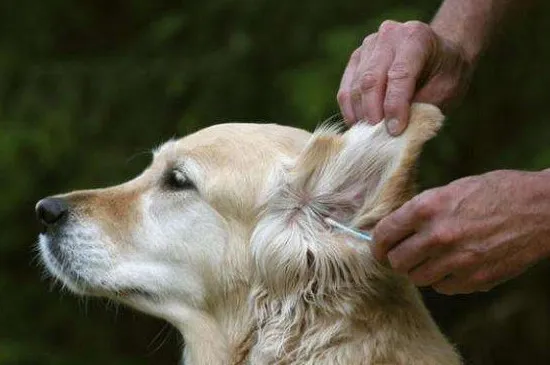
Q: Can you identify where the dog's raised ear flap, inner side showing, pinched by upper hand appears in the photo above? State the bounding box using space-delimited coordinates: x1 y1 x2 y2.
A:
290 104 444 227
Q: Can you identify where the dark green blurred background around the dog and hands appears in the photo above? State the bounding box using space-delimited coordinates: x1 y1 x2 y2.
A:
0 0 550 365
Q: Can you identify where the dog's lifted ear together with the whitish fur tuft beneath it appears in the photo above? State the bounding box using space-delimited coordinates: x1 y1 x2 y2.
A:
252 104 443 293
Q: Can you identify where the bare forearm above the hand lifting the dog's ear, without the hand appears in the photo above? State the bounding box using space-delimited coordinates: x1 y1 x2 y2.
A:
430 0 518 62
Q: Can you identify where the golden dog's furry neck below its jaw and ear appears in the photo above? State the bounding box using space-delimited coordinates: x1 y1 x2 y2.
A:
159 222 459 365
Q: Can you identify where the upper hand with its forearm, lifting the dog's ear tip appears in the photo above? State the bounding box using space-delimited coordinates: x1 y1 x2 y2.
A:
337 0 512 135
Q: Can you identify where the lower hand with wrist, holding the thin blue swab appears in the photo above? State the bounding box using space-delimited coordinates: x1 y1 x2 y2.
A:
373 171 550 295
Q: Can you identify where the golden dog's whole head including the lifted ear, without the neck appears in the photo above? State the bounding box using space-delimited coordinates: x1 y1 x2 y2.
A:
36 105 442 328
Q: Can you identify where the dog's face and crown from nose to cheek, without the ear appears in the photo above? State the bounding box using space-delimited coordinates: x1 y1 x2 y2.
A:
36 124 309 306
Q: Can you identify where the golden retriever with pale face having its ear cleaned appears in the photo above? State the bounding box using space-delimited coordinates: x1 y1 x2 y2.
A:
36 104 461 365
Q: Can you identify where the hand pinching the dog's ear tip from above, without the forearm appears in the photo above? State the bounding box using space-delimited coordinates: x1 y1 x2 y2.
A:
337 20 473 135
